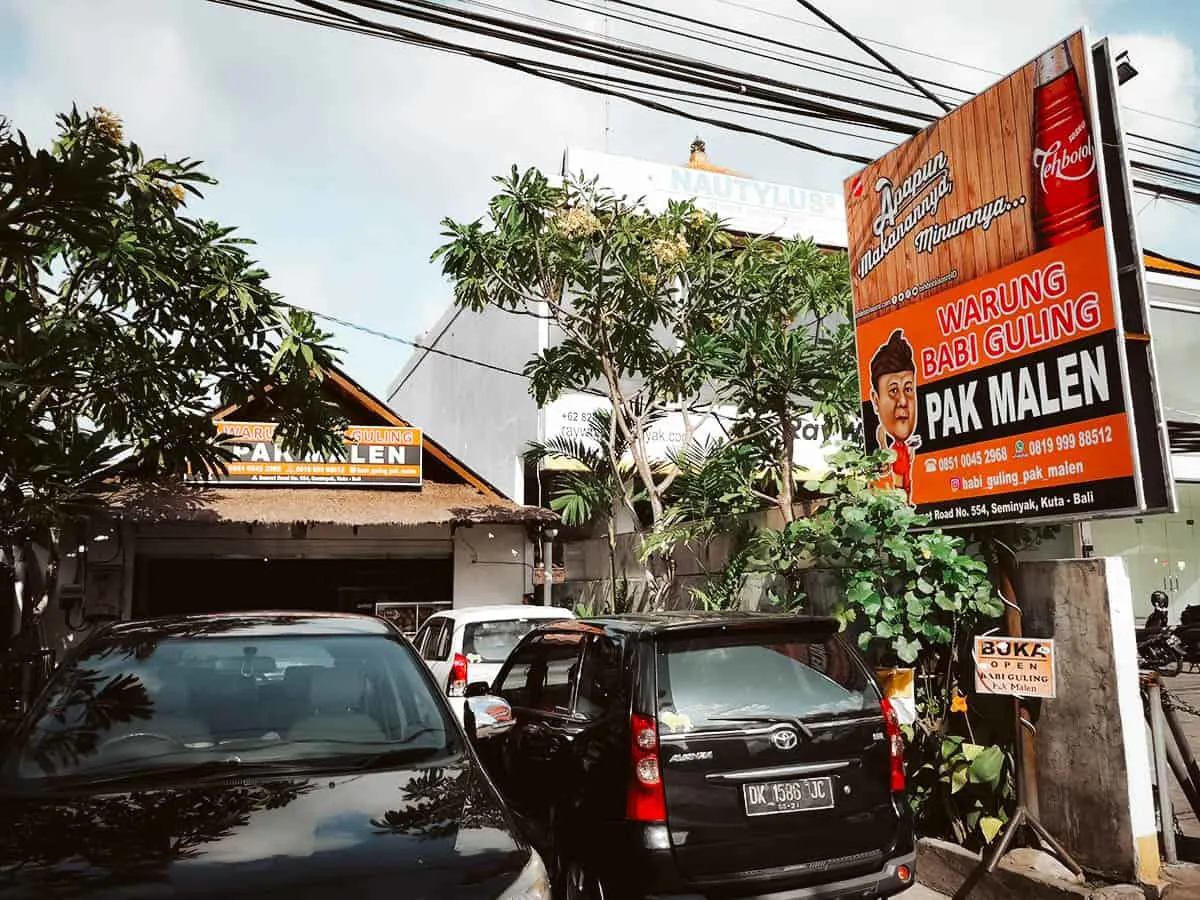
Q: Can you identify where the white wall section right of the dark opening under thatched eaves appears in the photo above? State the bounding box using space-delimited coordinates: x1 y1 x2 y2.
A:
454 526 533 608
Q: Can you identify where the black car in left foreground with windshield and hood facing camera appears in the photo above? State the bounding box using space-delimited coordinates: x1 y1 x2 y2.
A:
0 613 540 900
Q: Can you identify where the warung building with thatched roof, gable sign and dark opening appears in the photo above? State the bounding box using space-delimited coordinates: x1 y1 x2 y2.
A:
30 362 554 652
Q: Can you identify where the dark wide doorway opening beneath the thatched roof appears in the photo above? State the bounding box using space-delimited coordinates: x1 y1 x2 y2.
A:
133 557 454 618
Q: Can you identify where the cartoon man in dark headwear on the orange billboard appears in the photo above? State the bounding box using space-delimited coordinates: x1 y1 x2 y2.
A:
870 328 920 499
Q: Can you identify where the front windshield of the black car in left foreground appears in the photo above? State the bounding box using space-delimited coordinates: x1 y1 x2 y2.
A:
4 634 461 782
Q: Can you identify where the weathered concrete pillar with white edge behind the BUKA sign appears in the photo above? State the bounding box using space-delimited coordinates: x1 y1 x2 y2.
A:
1016 558 1159 883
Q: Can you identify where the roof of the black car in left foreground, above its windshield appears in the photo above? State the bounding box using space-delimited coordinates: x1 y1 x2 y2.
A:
97 610 396 638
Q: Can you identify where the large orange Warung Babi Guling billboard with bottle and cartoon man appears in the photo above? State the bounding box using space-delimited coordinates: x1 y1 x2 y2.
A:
845 32 1142 524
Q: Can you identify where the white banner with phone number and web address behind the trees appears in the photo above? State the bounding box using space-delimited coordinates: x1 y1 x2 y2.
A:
542 394 840 474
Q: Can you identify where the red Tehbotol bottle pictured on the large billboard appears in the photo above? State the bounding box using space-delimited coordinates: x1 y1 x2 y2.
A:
1033 42 1104 250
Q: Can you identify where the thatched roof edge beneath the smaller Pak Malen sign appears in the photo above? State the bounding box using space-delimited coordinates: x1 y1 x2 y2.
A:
104 481 558 527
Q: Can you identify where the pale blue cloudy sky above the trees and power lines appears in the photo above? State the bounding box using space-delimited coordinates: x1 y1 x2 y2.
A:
0 0 1200 396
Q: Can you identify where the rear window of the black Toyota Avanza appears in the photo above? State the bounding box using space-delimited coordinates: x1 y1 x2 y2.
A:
659 631 880 731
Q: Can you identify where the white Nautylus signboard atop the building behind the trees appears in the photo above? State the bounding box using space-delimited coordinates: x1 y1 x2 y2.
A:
563 148 846 247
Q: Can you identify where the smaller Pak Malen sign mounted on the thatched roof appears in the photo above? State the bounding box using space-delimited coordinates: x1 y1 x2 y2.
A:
188 421 421 487
